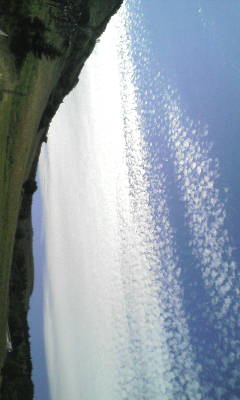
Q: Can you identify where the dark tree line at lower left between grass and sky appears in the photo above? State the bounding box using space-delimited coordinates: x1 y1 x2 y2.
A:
0 179 37 400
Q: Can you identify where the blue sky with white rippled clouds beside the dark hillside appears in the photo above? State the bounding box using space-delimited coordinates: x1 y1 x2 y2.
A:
30 0 240 400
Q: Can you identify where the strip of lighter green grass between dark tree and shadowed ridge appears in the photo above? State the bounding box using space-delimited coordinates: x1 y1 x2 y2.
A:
0 22 63 376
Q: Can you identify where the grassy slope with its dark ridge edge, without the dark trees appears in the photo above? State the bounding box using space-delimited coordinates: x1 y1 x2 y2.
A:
0 0 121 376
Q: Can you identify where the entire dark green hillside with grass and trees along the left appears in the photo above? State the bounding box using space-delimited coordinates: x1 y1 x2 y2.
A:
0 0 122 399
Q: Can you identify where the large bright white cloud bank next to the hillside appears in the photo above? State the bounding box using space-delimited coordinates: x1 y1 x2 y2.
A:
40 1 202 400
